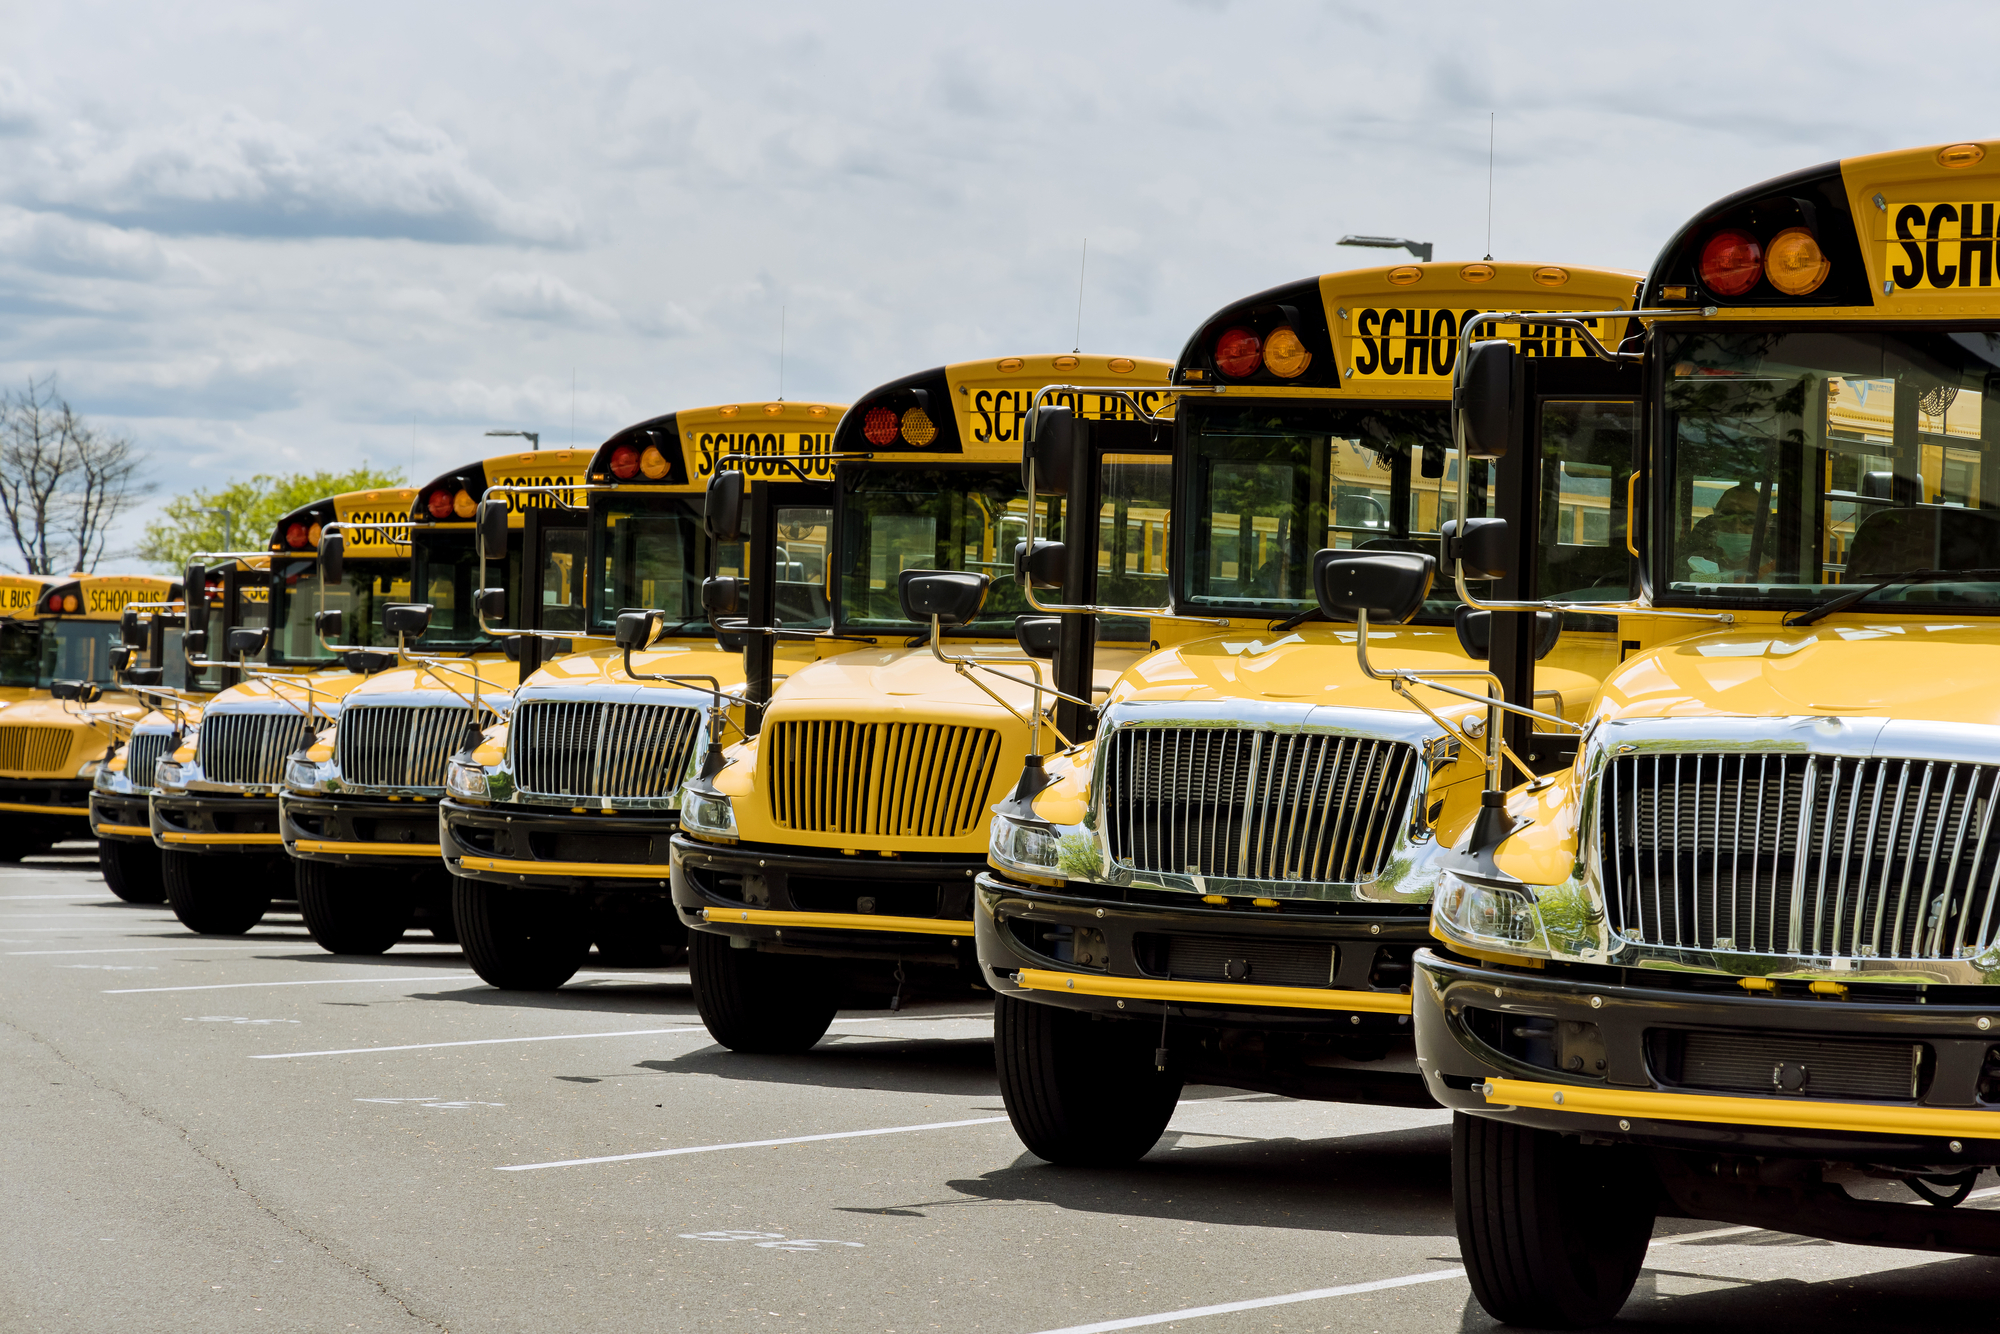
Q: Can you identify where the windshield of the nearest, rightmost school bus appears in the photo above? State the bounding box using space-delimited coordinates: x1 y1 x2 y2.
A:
1656 328 2000 610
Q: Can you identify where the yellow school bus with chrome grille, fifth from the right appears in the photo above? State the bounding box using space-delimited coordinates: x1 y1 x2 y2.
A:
280 450 592 954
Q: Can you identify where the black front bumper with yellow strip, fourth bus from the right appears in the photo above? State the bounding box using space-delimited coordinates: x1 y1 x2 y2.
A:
438 798 680 900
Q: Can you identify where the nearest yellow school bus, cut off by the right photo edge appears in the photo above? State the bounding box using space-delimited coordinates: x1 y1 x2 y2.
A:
1356 142 2000 1328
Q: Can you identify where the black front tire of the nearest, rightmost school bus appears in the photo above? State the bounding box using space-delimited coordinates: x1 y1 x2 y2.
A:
1452 1112 1658 1330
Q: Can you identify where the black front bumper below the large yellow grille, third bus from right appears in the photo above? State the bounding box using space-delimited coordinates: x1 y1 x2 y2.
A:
672 834 984 974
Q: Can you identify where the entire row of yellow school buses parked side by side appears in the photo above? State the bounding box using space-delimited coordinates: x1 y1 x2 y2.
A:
15 144 2000 1326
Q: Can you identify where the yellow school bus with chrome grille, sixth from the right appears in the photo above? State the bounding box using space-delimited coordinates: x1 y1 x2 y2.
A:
146 486 416 936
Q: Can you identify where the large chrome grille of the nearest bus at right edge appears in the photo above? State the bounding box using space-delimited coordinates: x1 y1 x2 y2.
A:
1600 754 2000 958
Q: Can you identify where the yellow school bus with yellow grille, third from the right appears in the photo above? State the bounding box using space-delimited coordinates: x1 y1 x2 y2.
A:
672 354 1168 1052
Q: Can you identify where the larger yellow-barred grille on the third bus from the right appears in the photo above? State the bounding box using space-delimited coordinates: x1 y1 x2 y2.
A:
764 718 1000 838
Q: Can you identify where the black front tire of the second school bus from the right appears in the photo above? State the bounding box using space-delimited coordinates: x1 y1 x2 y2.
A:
994 996 1180 1168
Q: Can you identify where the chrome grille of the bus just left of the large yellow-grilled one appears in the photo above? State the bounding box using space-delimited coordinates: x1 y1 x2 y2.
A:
508 700 702 800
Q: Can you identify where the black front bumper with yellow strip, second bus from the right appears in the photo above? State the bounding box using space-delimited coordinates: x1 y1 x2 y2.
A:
972 872 1430 1106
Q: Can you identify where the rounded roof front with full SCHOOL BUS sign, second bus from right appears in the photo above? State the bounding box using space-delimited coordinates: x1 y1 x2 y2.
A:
1174 260 1640 402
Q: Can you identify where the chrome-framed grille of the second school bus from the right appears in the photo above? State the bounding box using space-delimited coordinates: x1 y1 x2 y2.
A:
1104 728 1416 884
